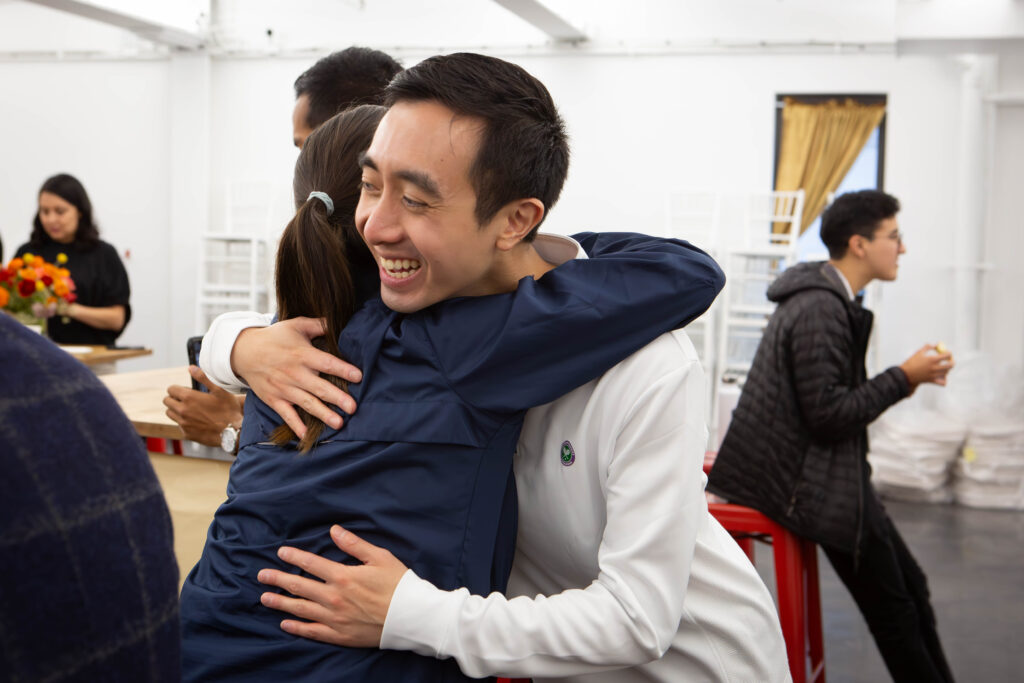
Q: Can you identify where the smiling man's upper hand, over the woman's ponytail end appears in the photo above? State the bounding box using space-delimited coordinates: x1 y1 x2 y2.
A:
231 317 362 437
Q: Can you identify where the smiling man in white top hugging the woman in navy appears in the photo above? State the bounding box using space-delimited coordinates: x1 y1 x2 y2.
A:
216 55 788 683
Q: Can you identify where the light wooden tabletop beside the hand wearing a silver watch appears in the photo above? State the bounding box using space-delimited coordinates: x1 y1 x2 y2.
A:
99 366 191 439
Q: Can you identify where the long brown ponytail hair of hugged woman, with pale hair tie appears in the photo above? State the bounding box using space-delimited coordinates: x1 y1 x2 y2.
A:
270 104 386 453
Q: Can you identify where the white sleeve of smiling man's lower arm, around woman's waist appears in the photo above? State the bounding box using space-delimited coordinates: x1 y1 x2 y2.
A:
381 354 708 677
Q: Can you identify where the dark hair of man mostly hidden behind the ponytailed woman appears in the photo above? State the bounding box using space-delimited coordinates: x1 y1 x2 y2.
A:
295 47 401 129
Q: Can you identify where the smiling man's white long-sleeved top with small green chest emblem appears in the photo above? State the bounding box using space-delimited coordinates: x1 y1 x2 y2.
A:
203 234 791 683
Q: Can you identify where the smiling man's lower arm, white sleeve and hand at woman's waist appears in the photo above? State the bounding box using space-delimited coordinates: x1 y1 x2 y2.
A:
260 337 708 676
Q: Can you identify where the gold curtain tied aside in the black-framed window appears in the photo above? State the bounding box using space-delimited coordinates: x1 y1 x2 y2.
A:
772 97 886 234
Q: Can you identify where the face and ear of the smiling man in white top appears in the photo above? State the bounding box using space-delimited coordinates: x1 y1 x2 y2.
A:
355 100 551 312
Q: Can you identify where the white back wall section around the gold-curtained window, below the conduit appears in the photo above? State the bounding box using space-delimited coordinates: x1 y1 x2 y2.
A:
203 53 962 376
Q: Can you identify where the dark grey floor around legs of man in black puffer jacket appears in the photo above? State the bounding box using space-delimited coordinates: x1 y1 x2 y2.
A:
757 501 1024 683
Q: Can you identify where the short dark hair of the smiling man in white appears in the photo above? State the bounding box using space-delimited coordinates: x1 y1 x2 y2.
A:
384 52 569 237
